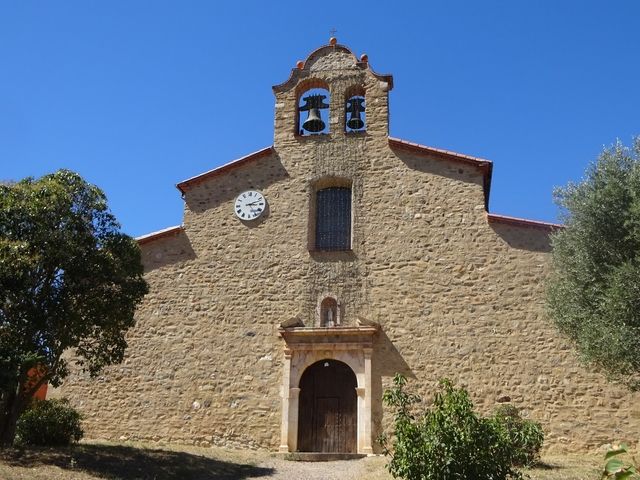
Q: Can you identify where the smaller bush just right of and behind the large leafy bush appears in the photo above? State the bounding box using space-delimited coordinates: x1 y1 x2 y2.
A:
491 405 544 467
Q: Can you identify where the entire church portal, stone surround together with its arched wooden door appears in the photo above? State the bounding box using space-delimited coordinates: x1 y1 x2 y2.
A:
279 323 380 454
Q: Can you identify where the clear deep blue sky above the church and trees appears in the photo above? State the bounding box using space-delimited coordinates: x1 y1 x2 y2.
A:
0 0 640 236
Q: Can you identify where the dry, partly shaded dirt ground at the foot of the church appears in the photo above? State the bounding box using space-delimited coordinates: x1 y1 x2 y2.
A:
0 443 604 480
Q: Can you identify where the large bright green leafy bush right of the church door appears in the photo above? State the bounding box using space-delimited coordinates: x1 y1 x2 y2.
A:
381 374 536 480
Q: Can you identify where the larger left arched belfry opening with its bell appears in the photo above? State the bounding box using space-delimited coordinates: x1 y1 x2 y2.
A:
297 80 330 136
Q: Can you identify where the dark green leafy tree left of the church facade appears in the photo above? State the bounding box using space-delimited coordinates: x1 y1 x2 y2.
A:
0 170 147 446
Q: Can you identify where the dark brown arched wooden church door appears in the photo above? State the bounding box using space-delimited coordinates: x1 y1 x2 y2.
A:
298 359 358 453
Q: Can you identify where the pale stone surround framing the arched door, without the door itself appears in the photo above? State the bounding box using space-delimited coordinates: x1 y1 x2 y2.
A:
279 326 379 454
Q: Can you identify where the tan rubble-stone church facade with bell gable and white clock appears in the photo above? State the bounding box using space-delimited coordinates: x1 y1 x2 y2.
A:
61 39 640 454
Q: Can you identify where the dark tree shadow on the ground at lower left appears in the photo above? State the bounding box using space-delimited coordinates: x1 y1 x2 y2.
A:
0 444 274 480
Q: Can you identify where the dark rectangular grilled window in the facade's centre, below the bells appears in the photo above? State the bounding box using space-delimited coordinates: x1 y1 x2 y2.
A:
315 187 351 250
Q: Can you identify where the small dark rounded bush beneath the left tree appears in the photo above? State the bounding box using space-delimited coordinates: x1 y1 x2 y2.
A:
16 399 83 445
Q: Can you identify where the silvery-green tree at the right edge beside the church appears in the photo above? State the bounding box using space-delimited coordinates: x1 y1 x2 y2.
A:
547 137 640 390
